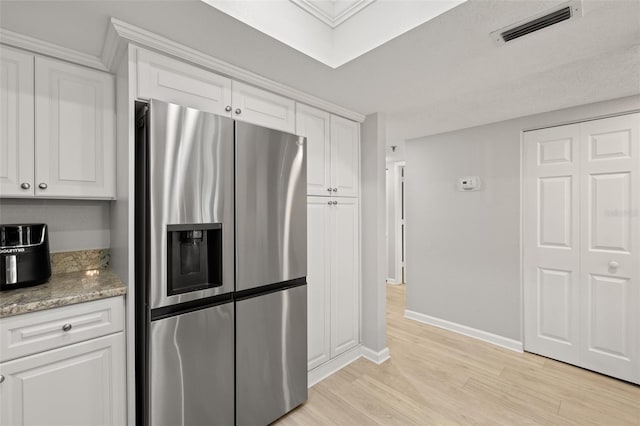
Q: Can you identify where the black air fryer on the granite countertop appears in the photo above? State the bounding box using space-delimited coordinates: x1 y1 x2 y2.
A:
0 223 51 290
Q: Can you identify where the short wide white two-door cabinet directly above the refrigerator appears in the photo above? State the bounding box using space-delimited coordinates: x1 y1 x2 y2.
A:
137 48 295 133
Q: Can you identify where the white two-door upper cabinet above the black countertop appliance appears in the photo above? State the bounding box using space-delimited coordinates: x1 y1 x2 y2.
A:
0 47 115 199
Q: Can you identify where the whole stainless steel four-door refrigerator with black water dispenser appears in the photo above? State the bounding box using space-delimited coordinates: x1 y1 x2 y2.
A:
133 100 307 426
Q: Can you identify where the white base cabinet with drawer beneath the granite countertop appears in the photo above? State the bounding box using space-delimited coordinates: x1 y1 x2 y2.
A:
0 297 126 426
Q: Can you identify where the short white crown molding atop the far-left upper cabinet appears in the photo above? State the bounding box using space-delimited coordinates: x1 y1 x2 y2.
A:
0 28 108 71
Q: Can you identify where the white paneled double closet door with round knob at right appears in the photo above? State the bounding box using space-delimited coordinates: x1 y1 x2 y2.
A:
523 114 640 383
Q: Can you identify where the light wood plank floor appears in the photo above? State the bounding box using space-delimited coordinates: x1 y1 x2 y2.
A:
277 286 640 426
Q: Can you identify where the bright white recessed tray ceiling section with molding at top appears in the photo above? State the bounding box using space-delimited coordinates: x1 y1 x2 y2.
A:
202 0 464 68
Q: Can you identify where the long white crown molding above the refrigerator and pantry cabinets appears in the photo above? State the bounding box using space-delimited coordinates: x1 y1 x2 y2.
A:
102 18 365 122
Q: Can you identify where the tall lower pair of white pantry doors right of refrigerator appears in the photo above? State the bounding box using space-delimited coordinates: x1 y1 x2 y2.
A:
307 197 360 370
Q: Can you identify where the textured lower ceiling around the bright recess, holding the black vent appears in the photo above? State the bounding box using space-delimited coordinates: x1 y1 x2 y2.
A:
0 0 640 158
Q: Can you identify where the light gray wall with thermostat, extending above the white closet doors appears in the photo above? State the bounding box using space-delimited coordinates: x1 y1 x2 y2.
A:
405 96 640 341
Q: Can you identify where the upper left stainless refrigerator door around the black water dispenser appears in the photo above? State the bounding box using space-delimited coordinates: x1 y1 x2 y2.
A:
146 100 234 309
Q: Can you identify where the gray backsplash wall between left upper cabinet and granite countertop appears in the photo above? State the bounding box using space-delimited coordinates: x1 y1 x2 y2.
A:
0 199 110 253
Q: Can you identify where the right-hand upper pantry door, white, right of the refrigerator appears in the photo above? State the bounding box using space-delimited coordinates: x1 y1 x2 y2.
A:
331 115 360 197
